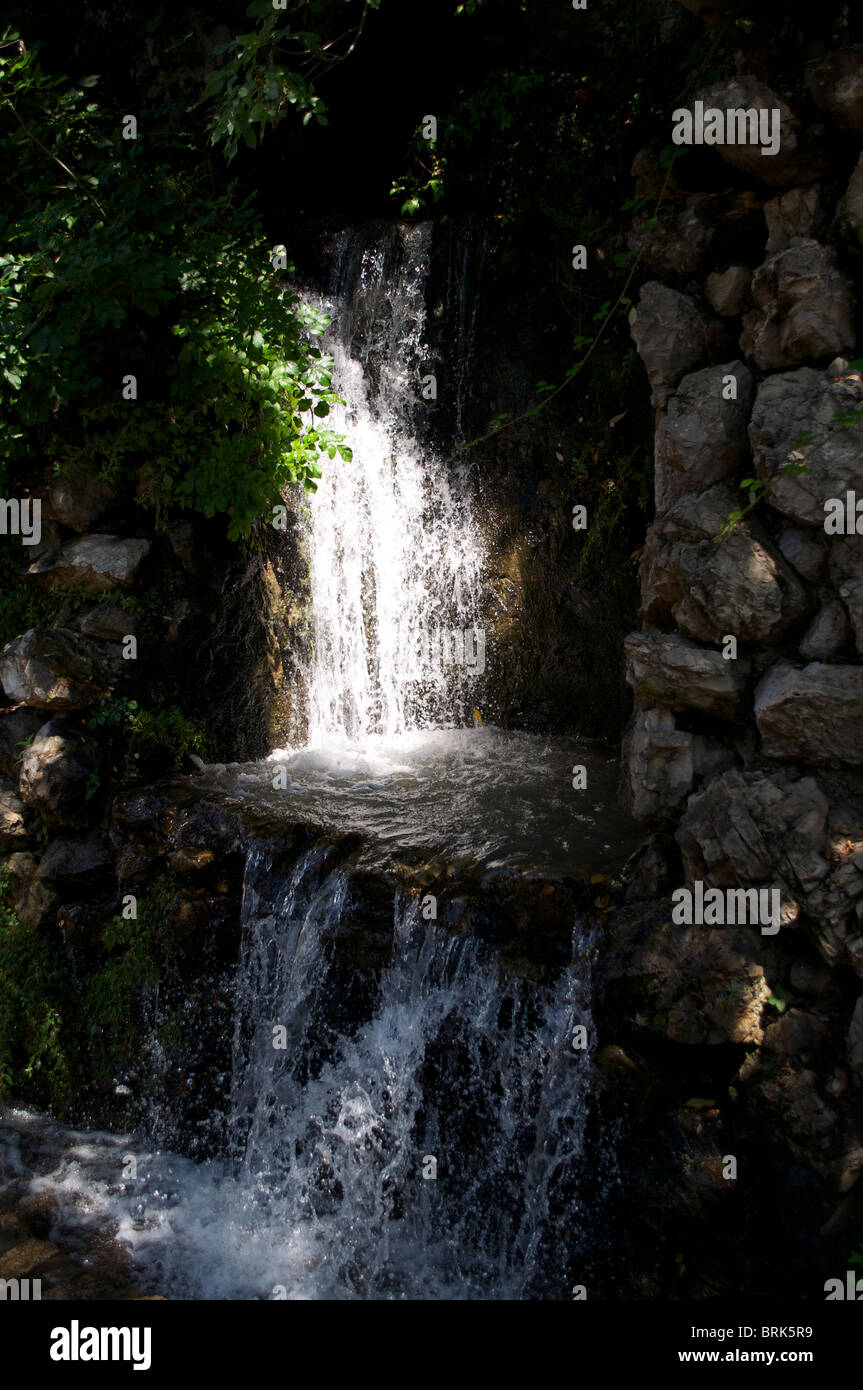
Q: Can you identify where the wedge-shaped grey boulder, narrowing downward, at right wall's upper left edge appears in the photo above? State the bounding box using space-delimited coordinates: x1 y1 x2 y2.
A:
632 281 725 409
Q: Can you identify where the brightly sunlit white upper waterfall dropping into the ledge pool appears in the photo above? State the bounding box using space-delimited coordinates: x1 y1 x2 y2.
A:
307 224 485 745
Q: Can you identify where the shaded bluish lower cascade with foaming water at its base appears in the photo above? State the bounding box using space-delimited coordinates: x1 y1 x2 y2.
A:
6 849 600 1300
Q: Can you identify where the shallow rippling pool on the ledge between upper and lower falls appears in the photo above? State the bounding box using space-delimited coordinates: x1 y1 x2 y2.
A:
194 726 643 876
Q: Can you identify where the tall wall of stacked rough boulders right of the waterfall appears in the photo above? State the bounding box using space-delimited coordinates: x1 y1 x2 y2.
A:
603 29 863 1297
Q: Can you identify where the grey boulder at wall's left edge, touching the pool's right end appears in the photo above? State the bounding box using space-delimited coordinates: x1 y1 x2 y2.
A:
621 706 734 821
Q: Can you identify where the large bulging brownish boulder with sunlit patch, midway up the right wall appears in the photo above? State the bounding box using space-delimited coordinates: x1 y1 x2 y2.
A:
641 484 807 644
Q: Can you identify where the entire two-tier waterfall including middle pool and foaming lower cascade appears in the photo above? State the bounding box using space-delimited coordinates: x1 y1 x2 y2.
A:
0 225 627 1298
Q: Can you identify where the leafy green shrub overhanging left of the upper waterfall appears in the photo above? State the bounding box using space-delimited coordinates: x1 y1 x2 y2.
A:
0 35 350 539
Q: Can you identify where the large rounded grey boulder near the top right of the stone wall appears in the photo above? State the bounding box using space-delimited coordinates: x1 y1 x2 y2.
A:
741 236 855 371
